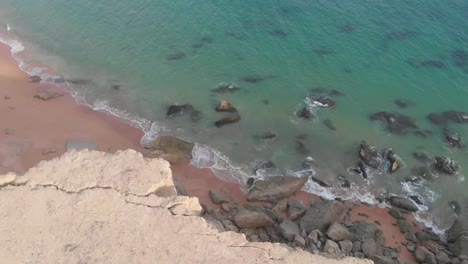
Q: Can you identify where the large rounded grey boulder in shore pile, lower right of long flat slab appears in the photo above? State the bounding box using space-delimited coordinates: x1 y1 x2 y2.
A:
300 201 347 232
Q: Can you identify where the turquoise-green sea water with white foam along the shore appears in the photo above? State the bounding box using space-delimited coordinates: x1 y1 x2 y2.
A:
0 0 468 231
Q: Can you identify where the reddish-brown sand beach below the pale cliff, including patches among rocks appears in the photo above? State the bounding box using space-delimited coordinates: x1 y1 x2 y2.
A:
0 40 450 263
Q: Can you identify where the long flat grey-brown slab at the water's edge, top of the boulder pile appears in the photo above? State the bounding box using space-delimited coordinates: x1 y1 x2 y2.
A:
247 176 307 201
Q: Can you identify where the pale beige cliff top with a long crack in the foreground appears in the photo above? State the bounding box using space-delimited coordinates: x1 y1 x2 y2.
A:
0 150 372 264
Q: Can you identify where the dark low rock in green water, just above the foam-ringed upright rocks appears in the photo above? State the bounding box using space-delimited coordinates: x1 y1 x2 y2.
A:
370 111 418 135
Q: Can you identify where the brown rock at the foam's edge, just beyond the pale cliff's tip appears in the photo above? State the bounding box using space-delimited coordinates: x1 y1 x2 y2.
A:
145 136 194 163
